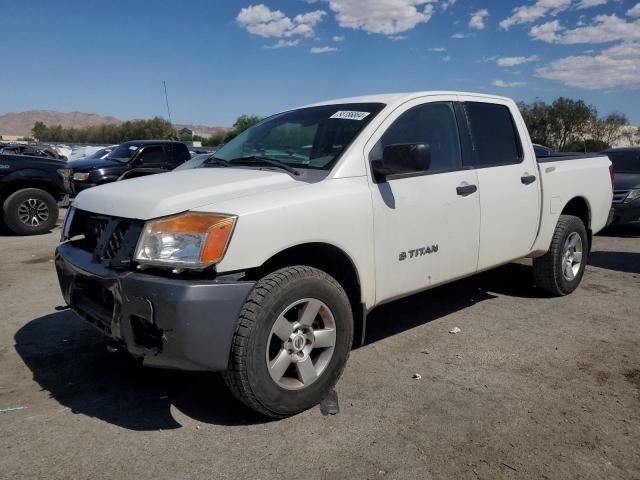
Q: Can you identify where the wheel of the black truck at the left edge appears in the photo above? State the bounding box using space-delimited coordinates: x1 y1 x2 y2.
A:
2 188 58 235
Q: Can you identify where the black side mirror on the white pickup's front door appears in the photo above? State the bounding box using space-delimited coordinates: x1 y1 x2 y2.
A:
371 143 431 179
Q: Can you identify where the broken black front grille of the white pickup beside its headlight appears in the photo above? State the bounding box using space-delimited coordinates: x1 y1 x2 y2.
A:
69 209 144 268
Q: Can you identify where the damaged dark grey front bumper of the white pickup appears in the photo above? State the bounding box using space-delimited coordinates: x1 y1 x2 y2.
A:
55 242 254 371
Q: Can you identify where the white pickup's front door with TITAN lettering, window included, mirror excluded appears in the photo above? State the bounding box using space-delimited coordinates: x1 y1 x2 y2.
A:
365 95 480 302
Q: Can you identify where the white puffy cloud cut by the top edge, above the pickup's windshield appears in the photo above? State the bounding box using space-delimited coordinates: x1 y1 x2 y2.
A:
329 0 434 35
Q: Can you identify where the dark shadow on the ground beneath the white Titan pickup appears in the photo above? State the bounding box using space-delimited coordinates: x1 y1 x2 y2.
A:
15 264 539 431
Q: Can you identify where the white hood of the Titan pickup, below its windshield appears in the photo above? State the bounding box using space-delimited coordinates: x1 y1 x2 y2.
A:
73 168 305 220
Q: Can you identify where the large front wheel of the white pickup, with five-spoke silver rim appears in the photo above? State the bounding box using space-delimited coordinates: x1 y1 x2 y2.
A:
223 266 353 418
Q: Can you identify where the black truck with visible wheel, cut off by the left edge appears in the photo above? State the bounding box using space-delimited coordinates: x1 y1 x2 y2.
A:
0 153 71 235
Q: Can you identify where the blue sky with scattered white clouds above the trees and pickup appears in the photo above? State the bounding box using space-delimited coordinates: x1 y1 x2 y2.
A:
0 0 640 125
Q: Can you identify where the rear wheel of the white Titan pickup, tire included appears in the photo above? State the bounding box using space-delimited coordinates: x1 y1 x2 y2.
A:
533 215 589 296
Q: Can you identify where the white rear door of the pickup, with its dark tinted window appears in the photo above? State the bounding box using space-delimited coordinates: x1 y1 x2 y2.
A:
460 96 540 270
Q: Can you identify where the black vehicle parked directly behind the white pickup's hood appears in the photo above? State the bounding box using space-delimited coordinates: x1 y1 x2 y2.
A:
71 140 191 194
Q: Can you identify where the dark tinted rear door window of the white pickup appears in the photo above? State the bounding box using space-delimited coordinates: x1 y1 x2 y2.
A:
465 102 523 167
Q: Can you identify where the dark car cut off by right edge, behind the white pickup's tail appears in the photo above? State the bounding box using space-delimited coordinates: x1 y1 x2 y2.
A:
602 147 640 224
